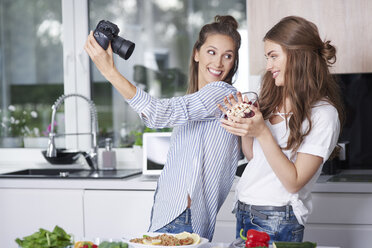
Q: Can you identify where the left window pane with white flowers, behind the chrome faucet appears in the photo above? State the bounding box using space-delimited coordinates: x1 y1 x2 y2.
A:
0 0 63 147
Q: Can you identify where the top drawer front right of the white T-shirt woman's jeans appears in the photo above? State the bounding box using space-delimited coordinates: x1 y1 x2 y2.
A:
307 193 372 225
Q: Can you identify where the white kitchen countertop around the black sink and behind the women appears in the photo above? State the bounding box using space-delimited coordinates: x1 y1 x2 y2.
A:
0 163 372 193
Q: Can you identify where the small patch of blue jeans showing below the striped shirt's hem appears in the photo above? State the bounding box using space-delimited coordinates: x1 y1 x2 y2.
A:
155 208 193 233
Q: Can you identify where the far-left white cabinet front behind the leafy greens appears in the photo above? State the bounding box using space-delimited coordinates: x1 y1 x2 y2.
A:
0 189 84 248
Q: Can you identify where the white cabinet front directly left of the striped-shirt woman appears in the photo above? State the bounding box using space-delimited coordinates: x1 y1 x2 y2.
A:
84 190 155 238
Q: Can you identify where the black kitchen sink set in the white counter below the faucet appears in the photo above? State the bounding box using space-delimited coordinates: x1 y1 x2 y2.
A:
0 168 141 179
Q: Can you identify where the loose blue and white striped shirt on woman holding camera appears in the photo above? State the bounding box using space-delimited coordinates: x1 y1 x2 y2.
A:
128 82 239 240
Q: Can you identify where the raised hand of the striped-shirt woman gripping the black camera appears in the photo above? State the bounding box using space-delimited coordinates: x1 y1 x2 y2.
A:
84 31 116 79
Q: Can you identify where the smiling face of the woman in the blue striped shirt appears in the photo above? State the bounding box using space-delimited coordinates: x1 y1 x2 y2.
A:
194 34 235 90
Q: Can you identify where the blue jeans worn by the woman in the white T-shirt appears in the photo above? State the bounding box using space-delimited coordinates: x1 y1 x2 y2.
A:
236 204 305 244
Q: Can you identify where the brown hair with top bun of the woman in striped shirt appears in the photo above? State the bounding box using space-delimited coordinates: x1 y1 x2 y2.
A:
187 15 241 94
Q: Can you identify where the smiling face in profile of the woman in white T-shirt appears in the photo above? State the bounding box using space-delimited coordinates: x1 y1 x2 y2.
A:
264 40 287 86
